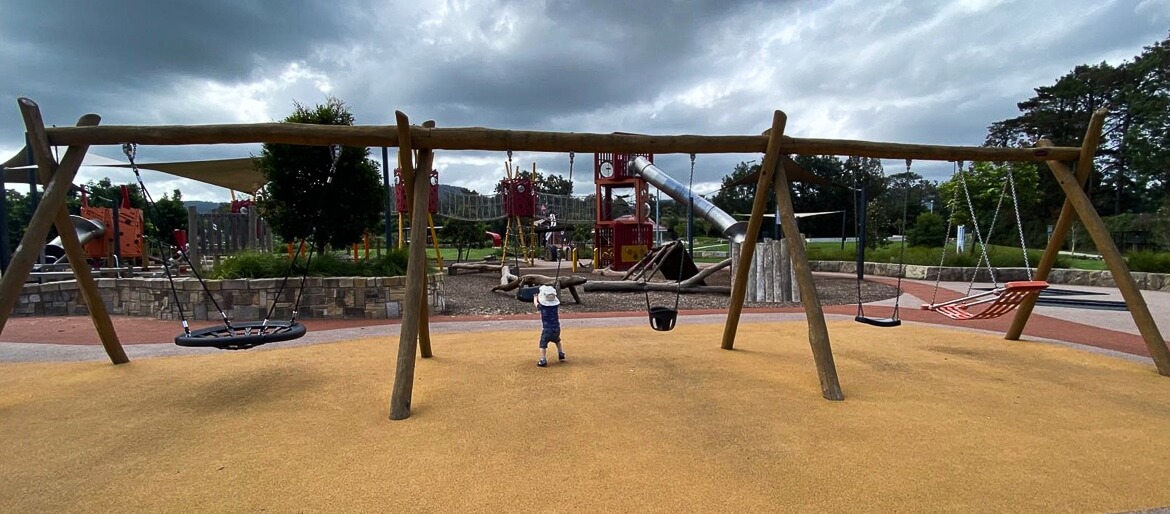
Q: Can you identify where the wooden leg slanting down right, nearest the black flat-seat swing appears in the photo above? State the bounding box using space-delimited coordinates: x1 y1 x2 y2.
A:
772 135 845 402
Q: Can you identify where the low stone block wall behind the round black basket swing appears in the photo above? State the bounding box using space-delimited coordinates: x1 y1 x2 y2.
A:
13 274 446 320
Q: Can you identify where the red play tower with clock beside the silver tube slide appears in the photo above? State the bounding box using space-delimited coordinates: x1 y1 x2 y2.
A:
593 153 654 272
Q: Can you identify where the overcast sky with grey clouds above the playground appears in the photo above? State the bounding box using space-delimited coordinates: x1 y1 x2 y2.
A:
0 0 1170 201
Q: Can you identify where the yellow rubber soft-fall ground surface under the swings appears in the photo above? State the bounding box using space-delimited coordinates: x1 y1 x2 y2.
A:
0 318 1170 513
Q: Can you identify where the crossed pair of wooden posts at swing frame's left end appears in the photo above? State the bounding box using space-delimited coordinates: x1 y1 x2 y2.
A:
0 98 130 364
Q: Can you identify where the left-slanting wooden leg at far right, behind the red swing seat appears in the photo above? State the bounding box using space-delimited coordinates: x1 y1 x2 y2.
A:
1004 108 1108 341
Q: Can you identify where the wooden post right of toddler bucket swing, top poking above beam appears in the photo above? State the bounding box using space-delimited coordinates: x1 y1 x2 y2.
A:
721 111 789 350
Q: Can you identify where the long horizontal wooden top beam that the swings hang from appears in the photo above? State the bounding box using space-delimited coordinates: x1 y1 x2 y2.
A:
38 123 1081 162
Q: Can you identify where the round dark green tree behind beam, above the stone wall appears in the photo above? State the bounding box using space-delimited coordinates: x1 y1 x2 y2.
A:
254 98 385 252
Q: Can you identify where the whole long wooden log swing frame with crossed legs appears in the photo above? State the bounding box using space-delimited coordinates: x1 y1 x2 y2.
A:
0 98 1170 419
